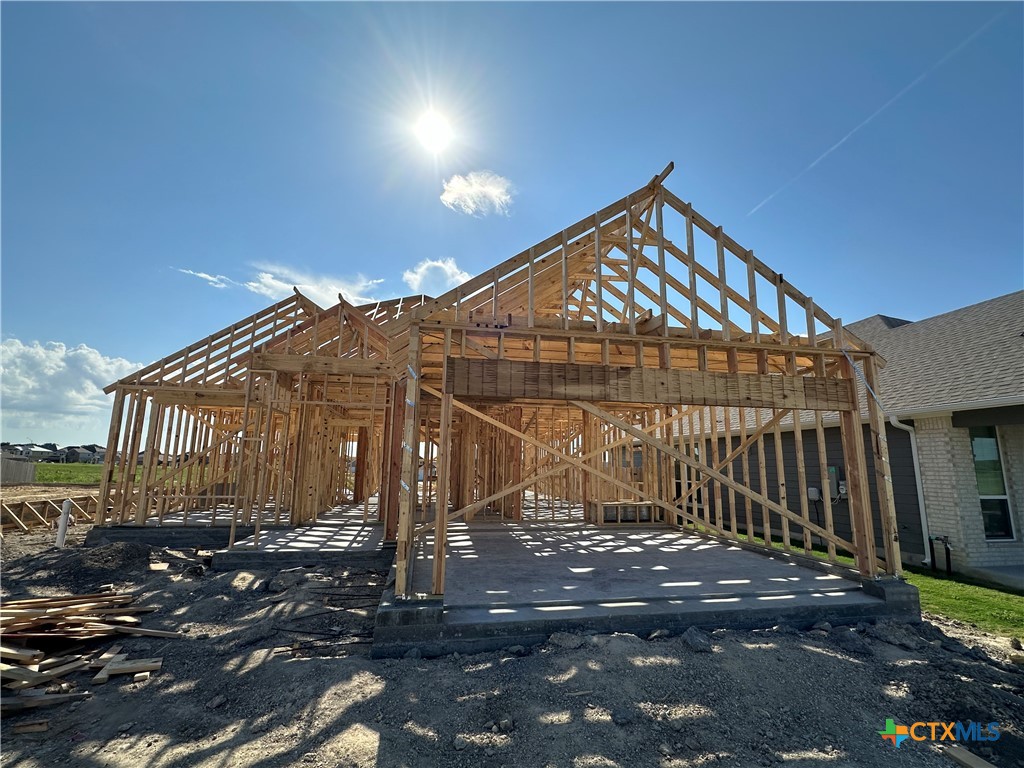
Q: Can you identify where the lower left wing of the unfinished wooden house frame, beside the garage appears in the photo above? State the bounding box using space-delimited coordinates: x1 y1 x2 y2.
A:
95 291 423 543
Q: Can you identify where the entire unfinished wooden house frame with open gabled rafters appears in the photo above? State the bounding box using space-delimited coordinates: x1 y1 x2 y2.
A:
96 165 900 597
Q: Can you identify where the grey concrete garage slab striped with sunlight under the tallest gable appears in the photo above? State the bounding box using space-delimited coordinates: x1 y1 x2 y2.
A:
373 523 921 656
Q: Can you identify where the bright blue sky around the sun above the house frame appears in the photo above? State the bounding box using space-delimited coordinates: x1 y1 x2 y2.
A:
0 2 1024 442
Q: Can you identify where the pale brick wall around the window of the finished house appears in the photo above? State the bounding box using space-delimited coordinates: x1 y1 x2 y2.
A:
914 415 1024 567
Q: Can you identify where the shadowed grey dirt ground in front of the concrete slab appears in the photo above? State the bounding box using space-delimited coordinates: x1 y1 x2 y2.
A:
0 526 1024 768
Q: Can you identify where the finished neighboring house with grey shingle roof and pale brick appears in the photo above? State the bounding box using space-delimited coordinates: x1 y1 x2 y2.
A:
848 291 1024 583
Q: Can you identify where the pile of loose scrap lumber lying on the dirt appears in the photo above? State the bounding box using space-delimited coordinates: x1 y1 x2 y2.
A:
0 592 180 712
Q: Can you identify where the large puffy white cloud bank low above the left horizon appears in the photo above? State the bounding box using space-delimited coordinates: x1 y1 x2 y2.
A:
0 339 142 444
